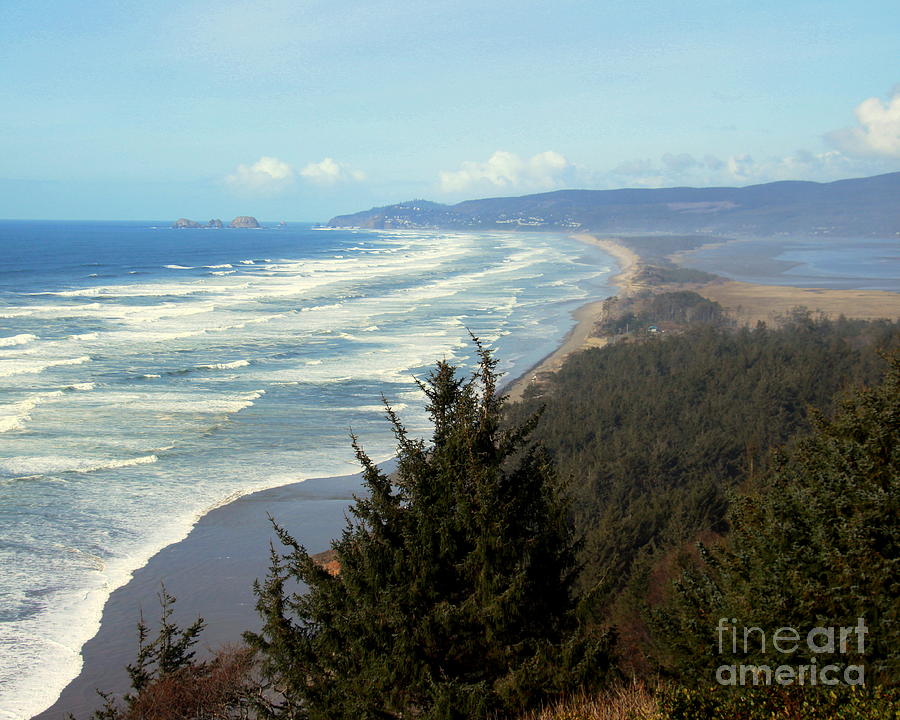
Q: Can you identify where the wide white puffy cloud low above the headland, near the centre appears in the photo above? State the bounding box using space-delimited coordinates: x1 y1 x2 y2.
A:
440 150 573 193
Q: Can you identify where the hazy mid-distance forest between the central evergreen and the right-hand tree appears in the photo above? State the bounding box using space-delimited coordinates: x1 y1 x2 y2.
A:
511 312 900 607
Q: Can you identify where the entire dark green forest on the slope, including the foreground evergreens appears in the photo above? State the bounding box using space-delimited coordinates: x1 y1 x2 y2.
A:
86 312 900 720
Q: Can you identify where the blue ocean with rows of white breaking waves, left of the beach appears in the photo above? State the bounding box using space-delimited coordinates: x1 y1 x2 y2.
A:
0 222 614 719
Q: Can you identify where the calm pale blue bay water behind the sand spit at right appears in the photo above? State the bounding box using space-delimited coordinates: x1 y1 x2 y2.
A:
683 237 900 292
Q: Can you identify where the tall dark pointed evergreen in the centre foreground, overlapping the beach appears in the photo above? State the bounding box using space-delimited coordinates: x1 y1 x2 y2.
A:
246 338 609 720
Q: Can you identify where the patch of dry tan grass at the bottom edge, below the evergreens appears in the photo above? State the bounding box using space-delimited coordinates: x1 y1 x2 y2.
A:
521 682 663 720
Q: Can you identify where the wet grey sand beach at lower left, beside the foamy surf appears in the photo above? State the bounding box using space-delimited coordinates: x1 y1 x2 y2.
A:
36 475 370 720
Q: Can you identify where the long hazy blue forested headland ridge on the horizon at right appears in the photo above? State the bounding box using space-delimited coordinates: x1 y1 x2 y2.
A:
328 172 900 237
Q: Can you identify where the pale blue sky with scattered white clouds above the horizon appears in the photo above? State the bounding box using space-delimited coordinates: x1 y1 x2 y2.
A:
0 0 900 221
